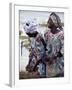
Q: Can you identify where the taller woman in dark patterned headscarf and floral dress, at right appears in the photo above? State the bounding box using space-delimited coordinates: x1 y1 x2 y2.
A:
44 12 64 77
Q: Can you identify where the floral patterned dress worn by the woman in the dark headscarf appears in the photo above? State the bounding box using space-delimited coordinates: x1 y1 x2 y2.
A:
44 30 64 74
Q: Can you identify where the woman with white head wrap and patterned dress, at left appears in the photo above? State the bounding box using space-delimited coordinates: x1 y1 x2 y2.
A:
24 19 46 76
